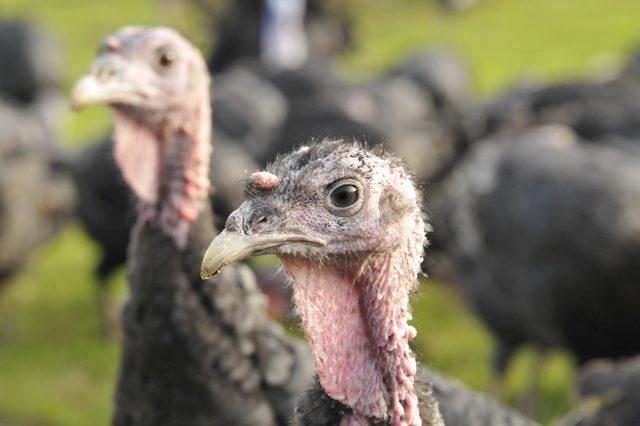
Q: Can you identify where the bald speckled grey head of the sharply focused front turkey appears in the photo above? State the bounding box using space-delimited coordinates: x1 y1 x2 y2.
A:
205 141 425 273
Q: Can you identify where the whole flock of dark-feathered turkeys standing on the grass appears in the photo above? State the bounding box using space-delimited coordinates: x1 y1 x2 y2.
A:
0 2 640 426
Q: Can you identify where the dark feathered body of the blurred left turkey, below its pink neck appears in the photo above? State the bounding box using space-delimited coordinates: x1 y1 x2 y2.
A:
114 205 311 425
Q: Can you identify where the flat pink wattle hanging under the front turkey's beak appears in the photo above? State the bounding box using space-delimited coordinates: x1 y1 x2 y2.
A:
282 259 388 419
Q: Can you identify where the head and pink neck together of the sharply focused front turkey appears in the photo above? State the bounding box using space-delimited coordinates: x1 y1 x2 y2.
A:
202 141 436 425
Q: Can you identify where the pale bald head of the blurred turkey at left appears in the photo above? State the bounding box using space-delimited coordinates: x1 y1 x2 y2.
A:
72 27 210 117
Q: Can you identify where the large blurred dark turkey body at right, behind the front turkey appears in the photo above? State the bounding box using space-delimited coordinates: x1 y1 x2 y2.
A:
432 121 640 402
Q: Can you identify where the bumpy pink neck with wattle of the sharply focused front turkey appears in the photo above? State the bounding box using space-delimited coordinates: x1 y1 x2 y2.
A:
282 240 422 426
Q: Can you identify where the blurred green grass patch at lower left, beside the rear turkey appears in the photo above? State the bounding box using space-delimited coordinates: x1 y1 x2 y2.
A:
0 227 124 425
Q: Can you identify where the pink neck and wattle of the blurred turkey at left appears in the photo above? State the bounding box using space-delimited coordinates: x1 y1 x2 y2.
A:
114 93 211 248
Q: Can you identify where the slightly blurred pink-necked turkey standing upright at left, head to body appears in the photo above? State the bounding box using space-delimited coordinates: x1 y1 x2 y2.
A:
72 27 311 425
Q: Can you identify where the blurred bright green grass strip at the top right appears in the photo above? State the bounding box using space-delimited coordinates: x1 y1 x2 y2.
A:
346 0 640 95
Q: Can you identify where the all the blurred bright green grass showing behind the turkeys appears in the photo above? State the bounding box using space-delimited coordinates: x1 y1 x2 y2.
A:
0 0 640 425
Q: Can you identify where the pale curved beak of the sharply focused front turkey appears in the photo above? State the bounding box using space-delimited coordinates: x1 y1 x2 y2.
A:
200 229 326 280
